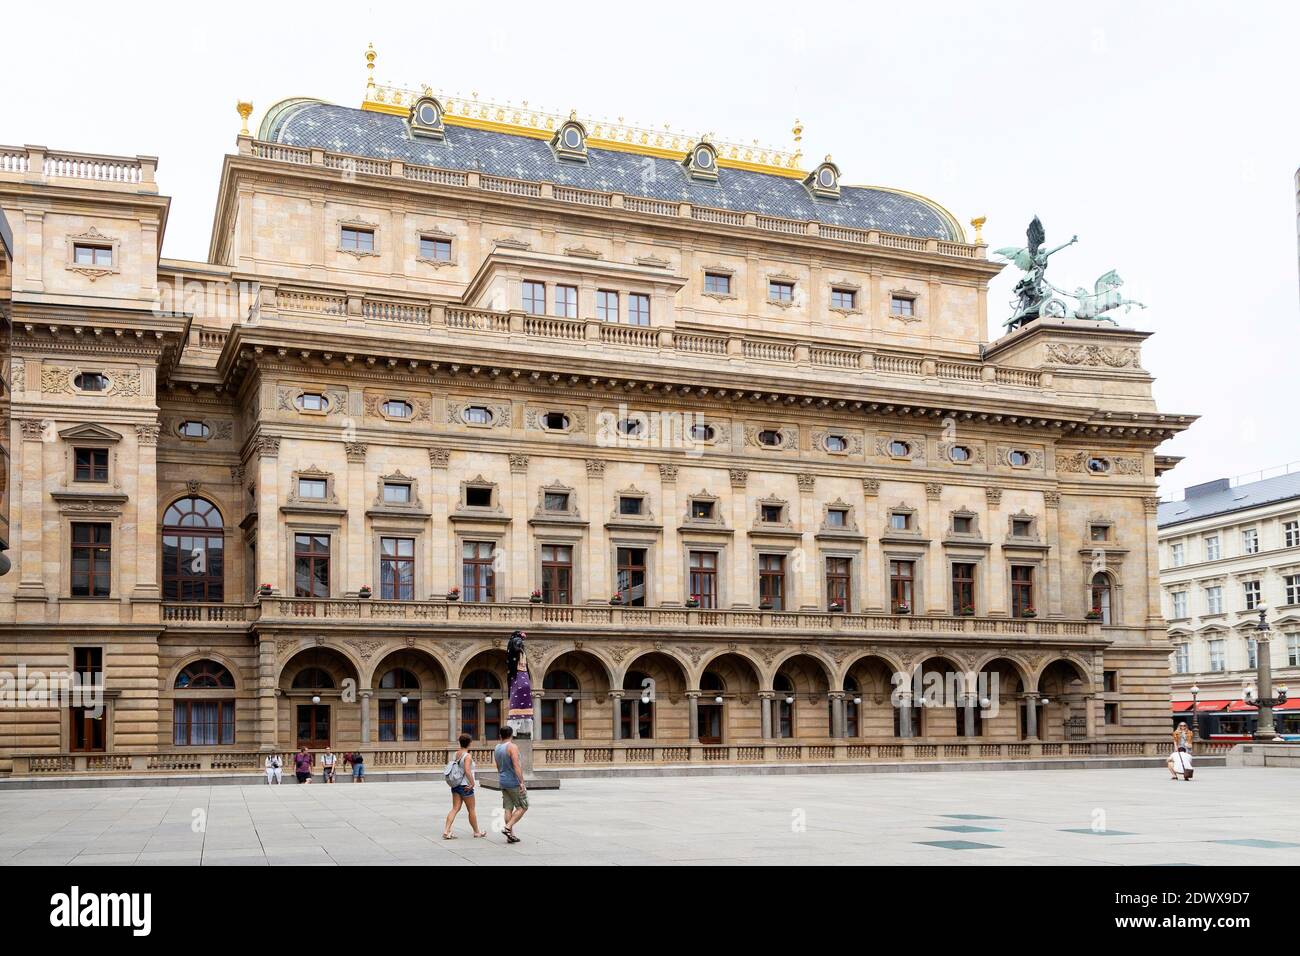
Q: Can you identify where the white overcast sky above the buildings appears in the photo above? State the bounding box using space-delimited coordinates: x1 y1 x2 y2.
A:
0 0 1300 493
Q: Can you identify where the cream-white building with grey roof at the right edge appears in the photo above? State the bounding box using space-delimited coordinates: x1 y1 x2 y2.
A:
1157 472 1300 735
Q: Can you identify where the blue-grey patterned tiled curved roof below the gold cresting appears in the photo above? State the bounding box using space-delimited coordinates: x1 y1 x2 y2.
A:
261 100 963 241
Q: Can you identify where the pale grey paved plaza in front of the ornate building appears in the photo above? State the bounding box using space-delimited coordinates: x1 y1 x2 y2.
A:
0 767 1300 866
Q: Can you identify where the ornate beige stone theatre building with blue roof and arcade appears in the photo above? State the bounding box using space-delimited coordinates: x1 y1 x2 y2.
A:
0 55 1191 773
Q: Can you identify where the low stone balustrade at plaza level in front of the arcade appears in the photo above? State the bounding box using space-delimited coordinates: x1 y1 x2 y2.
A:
12 737 1169 778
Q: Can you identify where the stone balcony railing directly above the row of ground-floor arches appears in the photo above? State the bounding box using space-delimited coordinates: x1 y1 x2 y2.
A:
163 596 1102 639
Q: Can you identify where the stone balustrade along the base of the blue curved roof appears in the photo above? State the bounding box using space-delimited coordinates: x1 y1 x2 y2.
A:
236 137 985 259
